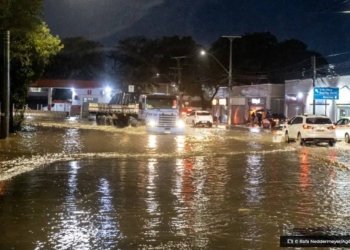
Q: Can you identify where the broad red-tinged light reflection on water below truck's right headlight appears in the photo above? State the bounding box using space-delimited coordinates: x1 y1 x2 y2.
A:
172 156 211 248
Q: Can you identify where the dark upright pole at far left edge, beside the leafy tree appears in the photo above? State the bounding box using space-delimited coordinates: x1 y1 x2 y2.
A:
0 31 10 139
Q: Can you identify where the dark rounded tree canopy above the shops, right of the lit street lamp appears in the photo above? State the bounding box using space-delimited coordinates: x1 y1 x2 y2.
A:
205 32 327 84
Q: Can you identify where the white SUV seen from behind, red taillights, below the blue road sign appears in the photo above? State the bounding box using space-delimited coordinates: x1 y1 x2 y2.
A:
284 115 336 147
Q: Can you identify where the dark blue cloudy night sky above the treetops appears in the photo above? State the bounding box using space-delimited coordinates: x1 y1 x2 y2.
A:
44 0 350 56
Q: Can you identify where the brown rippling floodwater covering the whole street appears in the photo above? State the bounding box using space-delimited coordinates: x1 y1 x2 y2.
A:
0 120 350 249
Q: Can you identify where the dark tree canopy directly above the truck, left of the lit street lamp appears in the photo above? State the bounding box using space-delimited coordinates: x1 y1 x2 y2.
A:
110 36 198 95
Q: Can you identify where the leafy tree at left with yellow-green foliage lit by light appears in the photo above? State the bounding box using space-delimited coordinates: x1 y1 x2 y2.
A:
0 0 62 131
